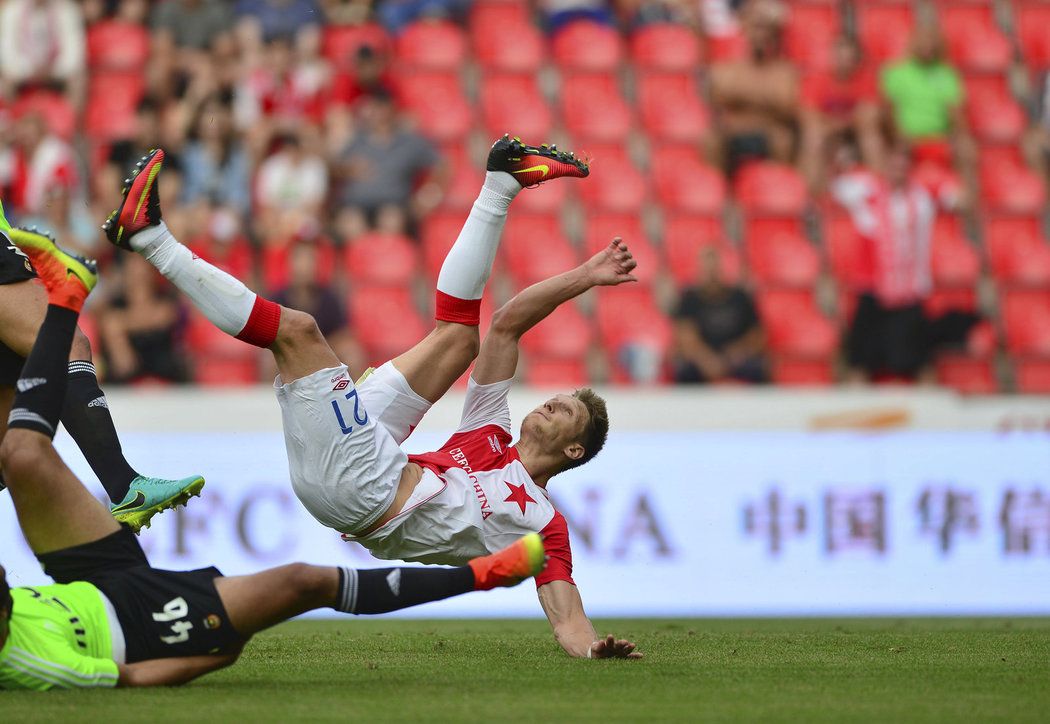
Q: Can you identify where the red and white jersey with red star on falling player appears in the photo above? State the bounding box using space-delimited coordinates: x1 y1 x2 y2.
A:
355 379 572 585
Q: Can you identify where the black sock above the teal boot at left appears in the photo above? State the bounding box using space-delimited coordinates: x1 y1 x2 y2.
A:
62 360 139 503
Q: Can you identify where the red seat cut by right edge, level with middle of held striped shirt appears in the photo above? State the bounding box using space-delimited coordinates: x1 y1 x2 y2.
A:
985 217 1050 288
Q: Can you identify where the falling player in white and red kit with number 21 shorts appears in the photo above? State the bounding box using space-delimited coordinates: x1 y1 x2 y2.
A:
103 136 641 658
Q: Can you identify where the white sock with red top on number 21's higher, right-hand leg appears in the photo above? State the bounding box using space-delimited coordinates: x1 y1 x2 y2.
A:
436 171 522 324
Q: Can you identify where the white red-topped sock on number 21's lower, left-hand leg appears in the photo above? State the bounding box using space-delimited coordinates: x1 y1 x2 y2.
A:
129 221 280 347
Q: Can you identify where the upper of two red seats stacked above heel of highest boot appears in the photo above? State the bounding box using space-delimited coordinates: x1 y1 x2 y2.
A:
470 10 547 73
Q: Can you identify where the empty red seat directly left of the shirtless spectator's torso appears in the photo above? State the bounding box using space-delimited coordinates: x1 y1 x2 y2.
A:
637 73 710 143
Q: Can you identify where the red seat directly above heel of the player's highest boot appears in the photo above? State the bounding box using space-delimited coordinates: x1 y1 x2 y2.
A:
481 73 553 142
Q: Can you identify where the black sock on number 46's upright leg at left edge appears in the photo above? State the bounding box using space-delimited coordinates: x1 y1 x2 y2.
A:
7 304 80 439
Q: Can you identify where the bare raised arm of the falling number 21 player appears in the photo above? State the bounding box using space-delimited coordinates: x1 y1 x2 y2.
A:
471 236 638 385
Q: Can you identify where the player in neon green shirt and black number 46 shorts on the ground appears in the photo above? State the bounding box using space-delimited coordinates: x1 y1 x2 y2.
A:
0 230 544 689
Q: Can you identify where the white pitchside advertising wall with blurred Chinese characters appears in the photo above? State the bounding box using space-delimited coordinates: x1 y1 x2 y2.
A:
0 389 1050 617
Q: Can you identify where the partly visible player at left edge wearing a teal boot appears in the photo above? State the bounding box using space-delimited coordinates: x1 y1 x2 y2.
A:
0 206 204 532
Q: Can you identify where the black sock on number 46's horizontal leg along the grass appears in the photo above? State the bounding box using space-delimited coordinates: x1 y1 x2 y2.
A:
332 566 474 614
